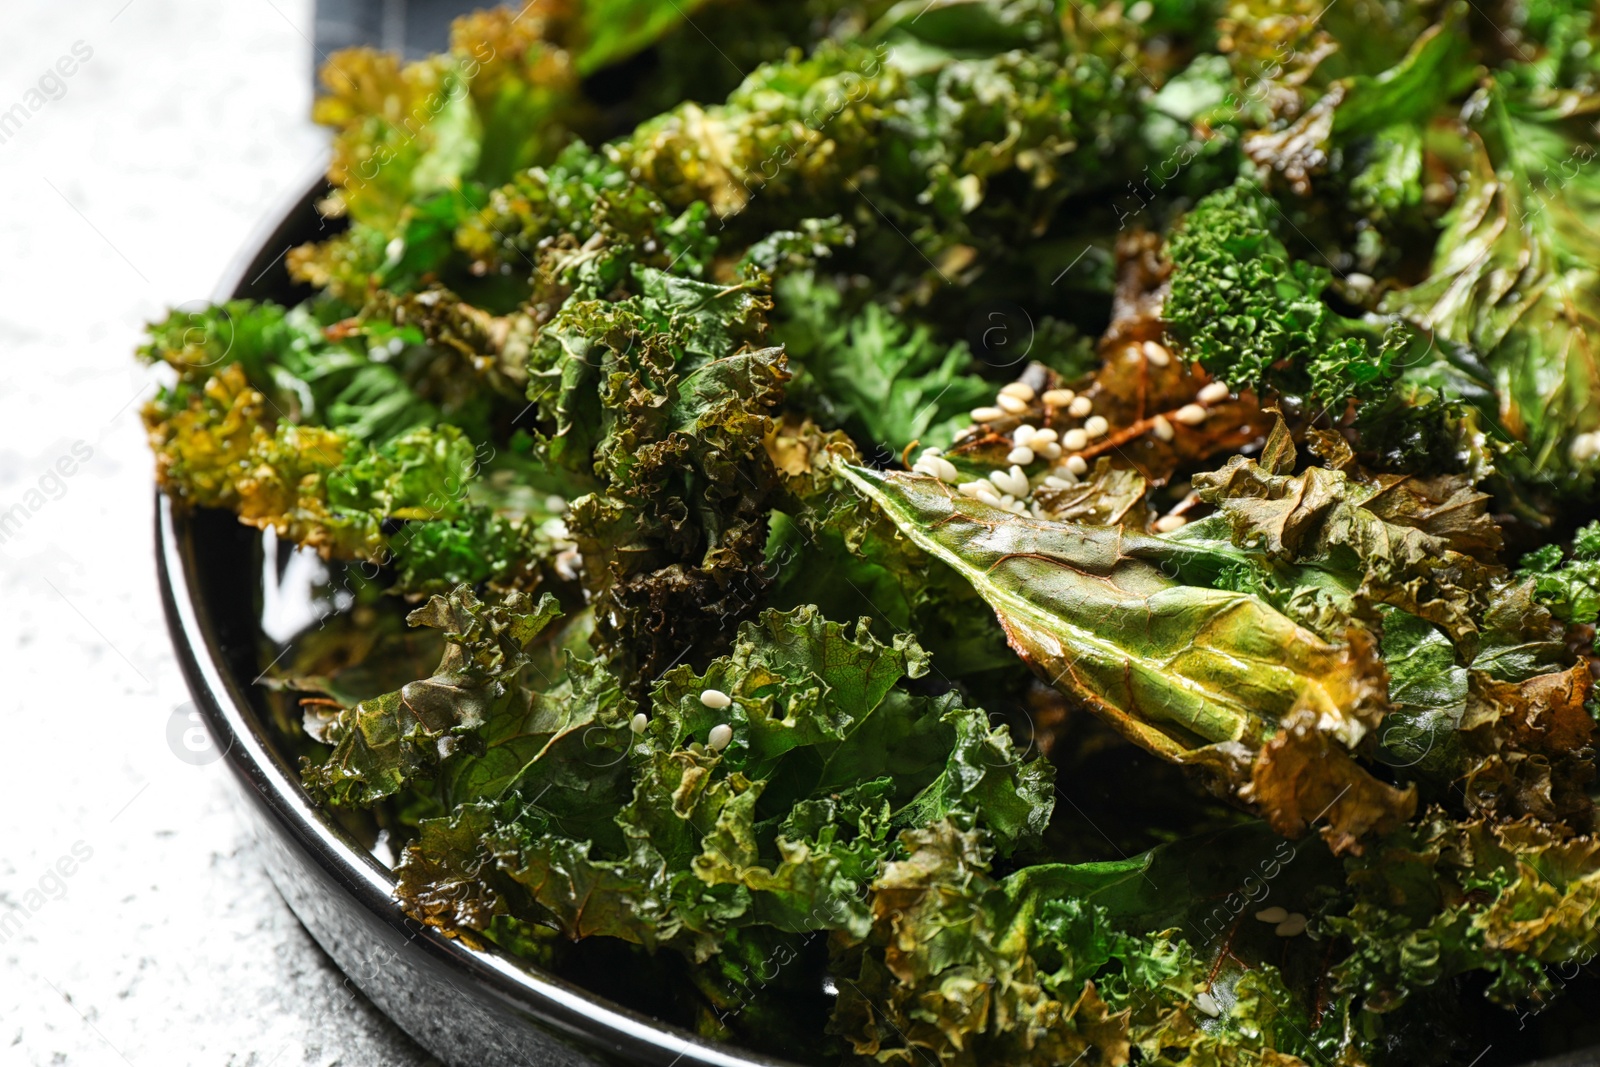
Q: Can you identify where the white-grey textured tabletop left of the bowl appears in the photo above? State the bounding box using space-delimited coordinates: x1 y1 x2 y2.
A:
0 0 430 1067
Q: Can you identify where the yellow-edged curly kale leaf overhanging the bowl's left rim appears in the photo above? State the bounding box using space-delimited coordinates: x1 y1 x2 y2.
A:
141 298 571 592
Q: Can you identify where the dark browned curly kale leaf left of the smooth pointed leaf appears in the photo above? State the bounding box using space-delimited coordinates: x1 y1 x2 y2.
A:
528 267 789 681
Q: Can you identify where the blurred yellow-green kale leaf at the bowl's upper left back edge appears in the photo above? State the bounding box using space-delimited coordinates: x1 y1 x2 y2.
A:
288 0 755 304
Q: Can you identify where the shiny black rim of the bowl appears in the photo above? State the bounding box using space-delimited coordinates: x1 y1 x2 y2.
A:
155 168 802 1067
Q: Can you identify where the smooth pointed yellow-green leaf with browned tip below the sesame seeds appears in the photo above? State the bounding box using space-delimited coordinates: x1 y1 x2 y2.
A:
843 467 1414 848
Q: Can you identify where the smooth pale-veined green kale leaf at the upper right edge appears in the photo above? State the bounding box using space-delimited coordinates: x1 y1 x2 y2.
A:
1382 75 1600 493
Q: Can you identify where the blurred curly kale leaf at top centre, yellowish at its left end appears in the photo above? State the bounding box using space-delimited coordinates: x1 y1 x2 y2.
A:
608 39 1138 278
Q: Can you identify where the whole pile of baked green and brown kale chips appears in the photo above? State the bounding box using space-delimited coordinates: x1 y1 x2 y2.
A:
139 0 1600 1067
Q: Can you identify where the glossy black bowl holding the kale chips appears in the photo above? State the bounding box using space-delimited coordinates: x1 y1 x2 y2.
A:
155 182 800 1067
